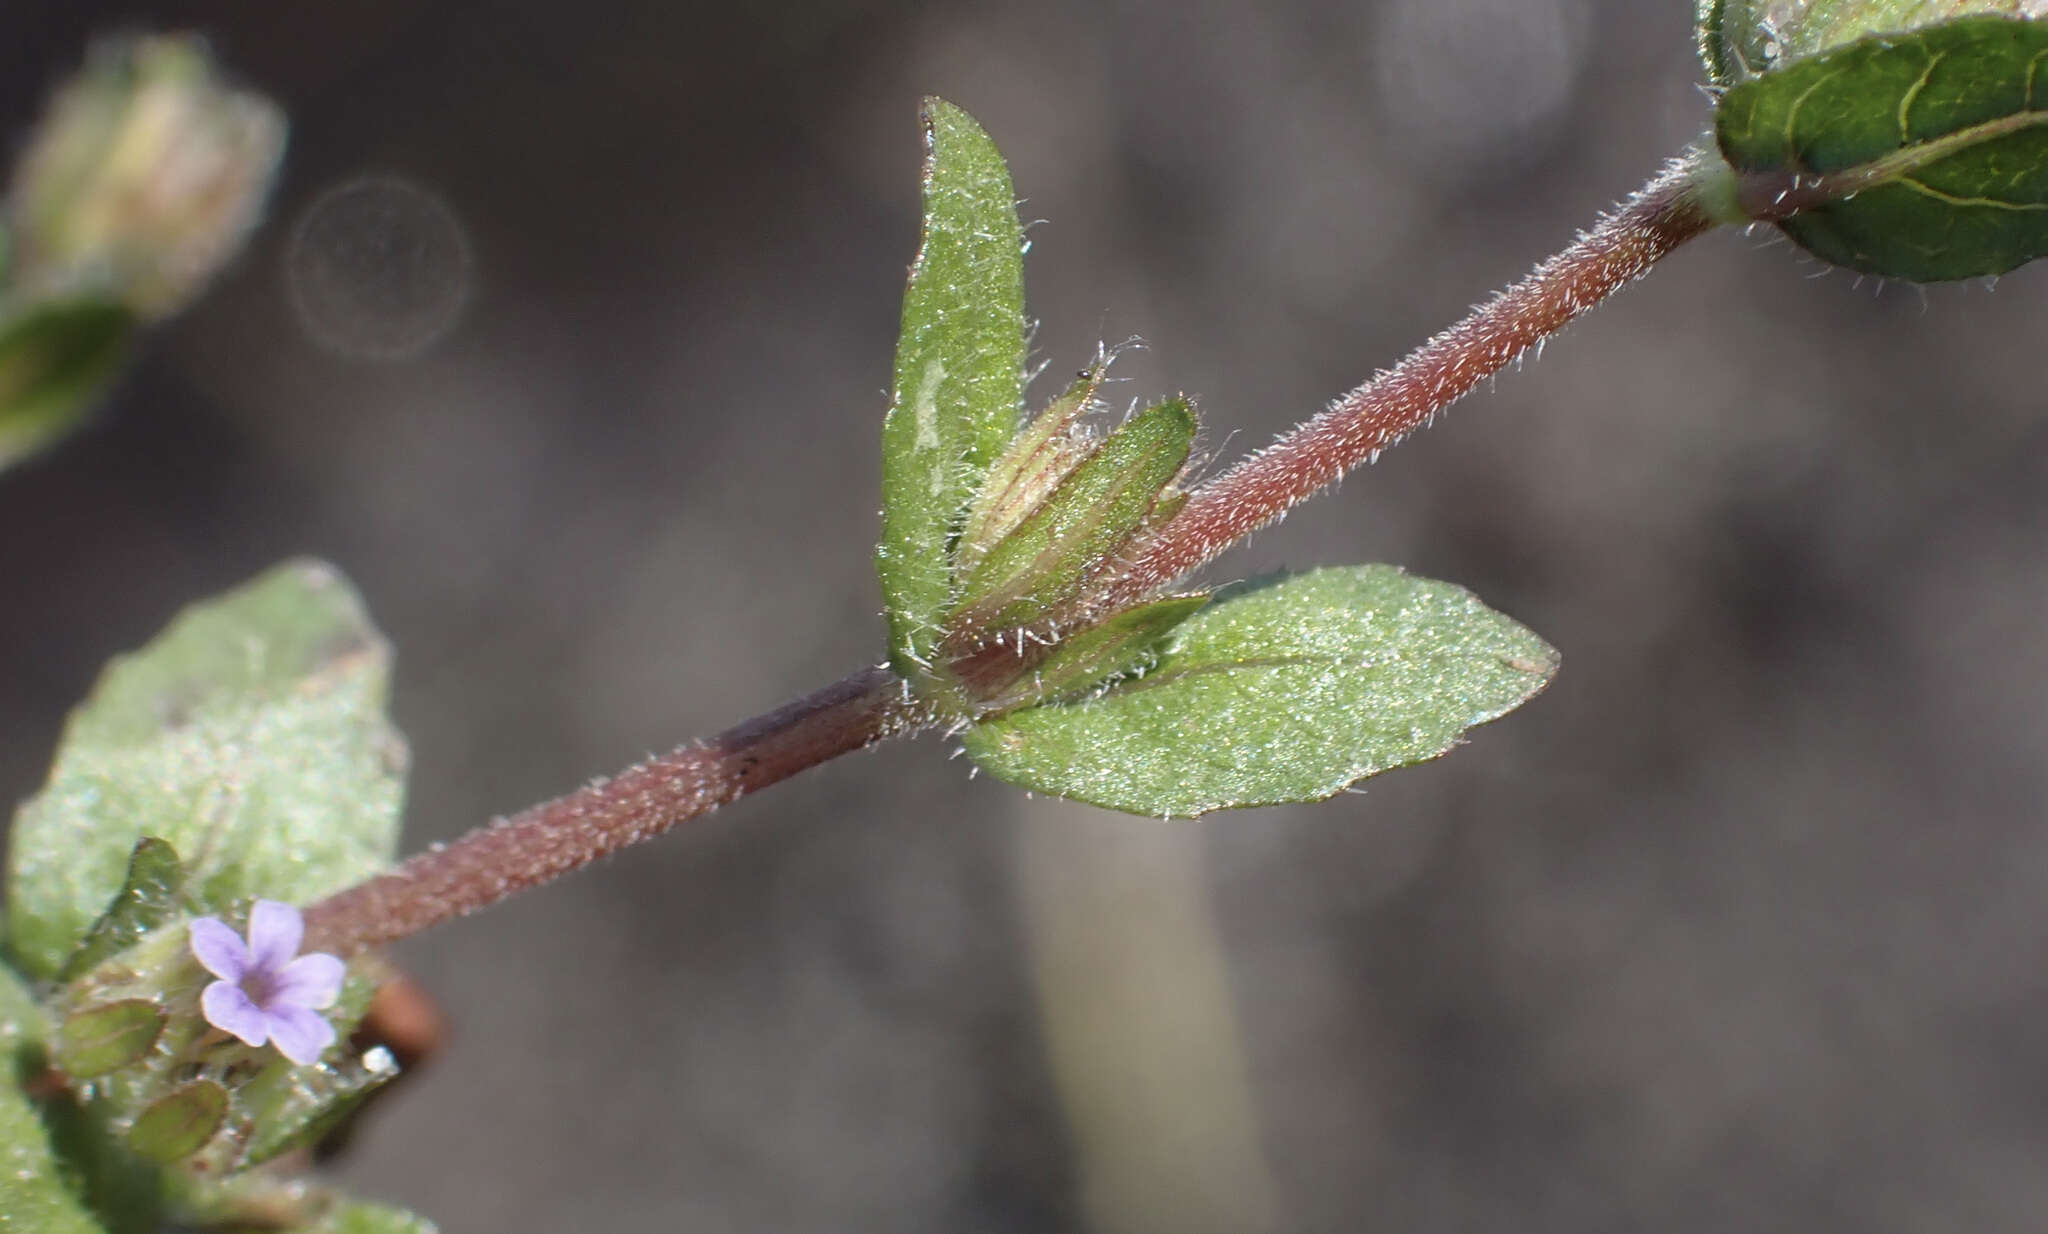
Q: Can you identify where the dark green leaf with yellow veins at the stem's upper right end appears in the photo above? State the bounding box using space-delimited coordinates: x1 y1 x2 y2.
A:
1714 16 2048 282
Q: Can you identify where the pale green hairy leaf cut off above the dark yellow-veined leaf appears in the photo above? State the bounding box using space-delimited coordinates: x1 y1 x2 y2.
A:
1700 0 2048 86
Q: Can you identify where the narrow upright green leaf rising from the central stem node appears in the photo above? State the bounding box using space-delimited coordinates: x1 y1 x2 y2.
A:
874 98 1024 679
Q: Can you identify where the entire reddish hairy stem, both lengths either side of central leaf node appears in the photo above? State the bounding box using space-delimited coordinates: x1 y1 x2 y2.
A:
305 147 1731 956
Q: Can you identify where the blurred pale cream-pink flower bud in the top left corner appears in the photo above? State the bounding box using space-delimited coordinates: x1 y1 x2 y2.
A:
8 37 285 317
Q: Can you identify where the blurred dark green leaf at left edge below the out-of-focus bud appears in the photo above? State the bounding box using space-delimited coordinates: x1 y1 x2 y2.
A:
0 299 135 469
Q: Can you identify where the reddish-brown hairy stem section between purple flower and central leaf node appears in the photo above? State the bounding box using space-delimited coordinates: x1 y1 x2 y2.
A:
305 669 928 956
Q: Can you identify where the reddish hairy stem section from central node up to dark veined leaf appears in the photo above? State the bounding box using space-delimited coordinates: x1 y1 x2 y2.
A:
1090 156 1726 614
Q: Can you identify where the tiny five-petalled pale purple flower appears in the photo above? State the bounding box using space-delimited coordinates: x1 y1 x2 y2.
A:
193 900 344 1064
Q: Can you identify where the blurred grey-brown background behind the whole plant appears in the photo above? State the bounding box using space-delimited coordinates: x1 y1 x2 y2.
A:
0 0 2048 1234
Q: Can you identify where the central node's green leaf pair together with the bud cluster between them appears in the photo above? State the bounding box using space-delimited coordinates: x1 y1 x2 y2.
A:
877 100 1556 817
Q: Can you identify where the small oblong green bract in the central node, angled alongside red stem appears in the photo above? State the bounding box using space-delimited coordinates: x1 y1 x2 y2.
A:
948 399 1194 630
